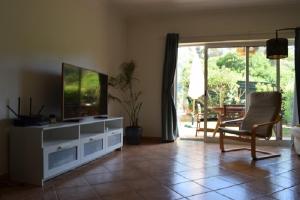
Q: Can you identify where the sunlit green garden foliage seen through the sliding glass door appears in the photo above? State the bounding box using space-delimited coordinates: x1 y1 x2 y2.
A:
177 47 294 127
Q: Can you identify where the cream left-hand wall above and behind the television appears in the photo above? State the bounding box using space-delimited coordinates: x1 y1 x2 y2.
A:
0 0 127 175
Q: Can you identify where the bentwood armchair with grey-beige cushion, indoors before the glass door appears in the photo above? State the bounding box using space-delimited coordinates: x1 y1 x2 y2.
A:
219 92 281 160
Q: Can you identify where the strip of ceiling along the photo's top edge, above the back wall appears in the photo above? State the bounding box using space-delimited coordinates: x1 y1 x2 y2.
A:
110 0 300 16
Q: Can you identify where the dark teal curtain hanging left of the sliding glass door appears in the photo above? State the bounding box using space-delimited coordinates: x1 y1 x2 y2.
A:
161 33 179 142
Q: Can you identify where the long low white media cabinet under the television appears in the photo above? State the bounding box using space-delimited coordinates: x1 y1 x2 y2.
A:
9 118 123 185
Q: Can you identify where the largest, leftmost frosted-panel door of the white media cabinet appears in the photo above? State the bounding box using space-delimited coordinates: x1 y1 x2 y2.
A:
44 141 79 179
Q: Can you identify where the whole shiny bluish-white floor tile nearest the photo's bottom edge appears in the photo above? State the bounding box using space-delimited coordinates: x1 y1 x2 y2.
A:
170 181 210 197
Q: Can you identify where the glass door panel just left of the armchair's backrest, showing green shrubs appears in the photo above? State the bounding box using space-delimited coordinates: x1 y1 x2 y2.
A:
207 47 246 137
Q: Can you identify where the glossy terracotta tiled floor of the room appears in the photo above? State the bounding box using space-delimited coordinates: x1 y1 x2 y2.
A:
0 140 300 200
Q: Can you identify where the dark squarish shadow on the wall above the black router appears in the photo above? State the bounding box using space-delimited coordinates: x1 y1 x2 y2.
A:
16 68 61 120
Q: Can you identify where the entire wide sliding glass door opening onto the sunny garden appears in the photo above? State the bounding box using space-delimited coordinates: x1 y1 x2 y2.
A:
175 40 295 139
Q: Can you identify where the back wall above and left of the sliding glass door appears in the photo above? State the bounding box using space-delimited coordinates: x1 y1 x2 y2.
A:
128 6 300 137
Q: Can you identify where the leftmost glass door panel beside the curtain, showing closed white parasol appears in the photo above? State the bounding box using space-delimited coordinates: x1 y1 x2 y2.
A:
175 46 204 138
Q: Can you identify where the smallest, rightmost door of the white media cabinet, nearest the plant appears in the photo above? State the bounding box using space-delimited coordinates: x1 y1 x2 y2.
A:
107 129 123 152
